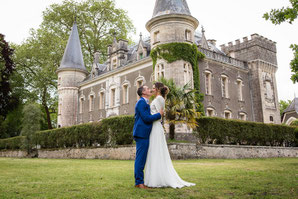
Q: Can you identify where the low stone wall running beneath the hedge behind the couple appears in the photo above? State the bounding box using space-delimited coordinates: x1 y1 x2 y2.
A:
0 143 298 160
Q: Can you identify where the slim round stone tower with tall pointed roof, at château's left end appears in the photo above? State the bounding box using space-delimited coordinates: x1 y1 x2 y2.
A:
57 22 88 127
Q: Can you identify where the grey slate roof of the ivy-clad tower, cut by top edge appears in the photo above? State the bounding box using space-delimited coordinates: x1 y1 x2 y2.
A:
152 0 191 18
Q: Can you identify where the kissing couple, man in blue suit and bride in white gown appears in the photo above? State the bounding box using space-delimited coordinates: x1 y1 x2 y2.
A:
133 82 195 189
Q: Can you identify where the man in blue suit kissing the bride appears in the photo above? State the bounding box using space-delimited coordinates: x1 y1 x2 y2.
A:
133 86 163 189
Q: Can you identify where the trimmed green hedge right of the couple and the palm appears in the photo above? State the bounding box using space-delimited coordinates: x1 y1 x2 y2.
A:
195 117 298 146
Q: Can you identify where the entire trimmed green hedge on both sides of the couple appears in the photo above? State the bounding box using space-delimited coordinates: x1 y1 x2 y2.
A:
0 115 298 150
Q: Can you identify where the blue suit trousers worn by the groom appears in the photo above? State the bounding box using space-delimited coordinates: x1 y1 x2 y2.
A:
134 138 149 185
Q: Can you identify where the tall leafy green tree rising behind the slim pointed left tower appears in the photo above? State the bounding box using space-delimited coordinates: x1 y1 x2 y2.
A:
41 0 135 67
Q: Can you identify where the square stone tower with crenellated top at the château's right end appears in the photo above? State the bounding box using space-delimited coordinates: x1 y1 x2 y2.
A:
221 34 281 124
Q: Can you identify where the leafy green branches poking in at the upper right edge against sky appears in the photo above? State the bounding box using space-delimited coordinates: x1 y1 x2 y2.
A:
263 0 298 83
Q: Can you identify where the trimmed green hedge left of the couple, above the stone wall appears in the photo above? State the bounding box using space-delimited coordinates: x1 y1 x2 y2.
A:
0 116 134 149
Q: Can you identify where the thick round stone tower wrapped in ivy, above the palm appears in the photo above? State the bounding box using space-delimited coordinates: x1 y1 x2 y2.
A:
146 0 199 86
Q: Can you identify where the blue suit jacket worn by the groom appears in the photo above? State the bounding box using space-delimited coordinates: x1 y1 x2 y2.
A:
133 98 161 139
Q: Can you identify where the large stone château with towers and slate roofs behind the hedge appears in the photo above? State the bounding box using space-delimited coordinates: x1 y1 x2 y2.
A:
57 0 281 127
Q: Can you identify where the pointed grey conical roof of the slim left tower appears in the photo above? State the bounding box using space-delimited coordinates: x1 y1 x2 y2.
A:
58 22 87 73
